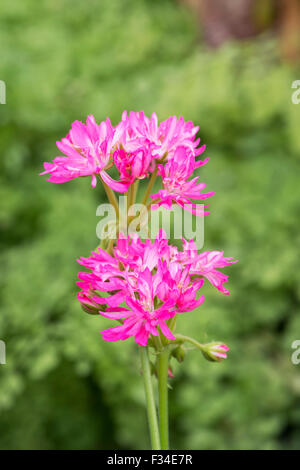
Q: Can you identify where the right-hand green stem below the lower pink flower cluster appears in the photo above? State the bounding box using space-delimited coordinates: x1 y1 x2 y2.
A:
158 348 169 450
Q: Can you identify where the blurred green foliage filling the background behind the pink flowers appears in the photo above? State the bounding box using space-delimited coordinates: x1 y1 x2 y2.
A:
0 0 300 449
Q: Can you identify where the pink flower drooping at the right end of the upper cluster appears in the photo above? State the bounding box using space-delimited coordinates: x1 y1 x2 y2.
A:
150 147 214 216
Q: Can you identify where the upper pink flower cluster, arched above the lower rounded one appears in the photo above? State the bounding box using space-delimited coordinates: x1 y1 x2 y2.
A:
41 111 214 215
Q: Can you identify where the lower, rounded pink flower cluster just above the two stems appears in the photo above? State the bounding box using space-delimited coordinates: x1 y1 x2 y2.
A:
77 230 235 346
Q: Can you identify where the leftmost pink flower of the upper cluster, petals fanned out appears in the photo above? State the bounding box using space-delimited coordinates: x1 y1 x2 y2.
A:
41 116 128 192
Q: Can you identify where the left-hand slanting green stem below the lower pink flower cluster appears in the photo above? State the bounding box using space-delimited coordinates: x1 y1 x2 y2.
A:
140 346 161 450
